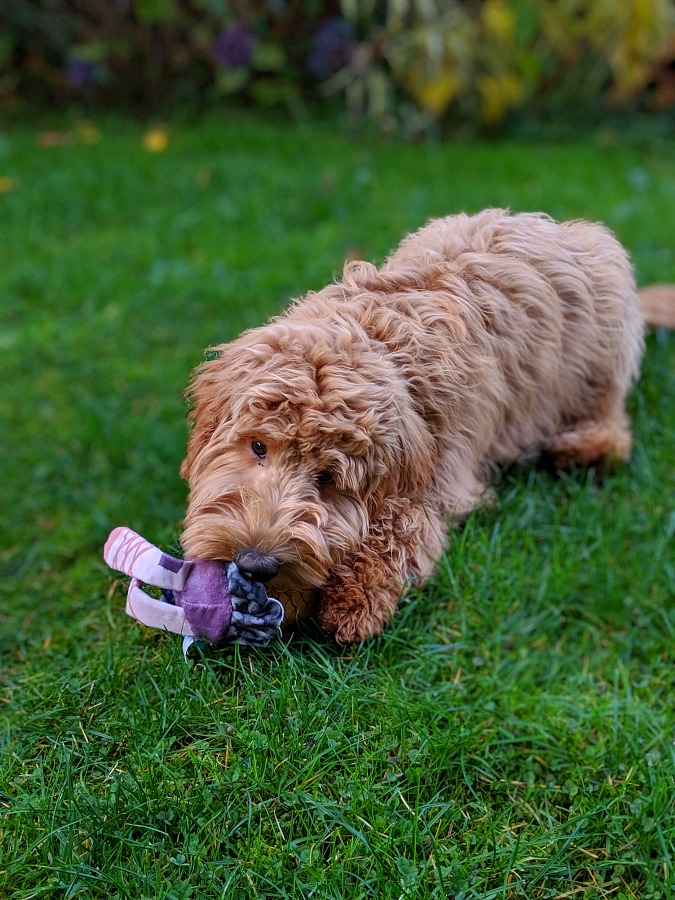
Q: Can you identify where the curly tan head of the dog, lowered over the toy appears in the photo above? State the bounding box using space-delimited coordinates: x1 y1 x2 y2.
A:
181 315 432 590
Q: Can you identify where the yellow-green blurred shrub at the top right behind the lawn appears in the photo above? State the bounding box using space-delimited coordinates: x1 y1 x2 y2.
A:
335 0 675 127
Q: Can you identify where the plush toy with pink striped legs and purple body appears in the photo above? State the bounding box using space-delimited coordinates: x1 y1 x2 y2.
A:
103 528 284 651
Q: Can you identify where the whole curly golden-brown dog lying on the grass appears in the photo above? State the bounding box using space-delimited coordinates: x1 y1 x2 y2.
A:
182 209 672 643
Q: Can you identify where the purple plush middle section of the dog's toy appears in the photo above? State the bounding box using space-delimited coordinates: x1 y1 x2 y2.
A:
174 559 232 644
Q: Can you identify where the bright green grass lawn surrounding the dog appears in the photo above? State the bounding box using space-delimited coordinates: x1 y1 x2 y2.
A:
0 118 675 900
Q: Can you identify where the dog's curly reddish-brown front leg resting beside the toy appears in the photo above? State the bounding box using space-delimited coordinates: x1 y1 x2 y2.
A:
319 498 445 644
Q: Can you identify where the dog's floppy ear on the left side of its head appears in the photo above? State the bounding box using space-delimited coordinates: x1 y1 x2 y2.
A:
180 344 237 479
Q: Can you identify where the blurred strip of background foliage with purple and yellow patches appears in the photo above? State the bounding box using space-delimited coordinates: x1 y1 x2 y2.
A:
0 0 675 134
